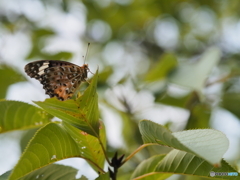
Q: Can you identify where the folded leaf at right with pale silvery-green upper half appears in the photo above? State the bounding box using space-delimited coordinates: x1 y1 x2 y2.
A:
139 120 229 166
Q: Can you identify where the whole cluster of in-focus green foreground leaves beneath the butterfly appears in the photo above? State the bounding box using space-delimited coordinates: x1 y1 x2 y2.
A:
0 69 236 180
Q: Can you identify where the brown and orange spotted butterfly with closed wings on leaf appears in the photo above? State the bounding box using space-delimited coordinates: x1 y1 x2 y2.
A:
25 60 91 101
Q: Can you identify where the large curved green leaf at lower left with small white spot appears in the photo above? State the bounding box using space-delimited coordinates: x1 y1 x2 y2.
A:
9 123 81 180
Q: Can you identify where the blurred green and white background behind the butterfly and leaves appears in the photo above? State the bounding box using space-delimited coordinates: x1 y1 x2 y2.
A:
0 0 240 179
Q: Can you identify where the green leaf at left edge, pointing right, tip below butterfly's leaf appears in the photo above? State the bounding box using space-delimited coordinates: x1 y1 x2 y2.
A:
0 100 52 133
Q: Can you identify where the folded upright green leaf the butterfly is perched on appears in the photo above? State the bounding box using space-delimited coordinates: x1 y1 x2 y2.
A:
35 72 99 137
